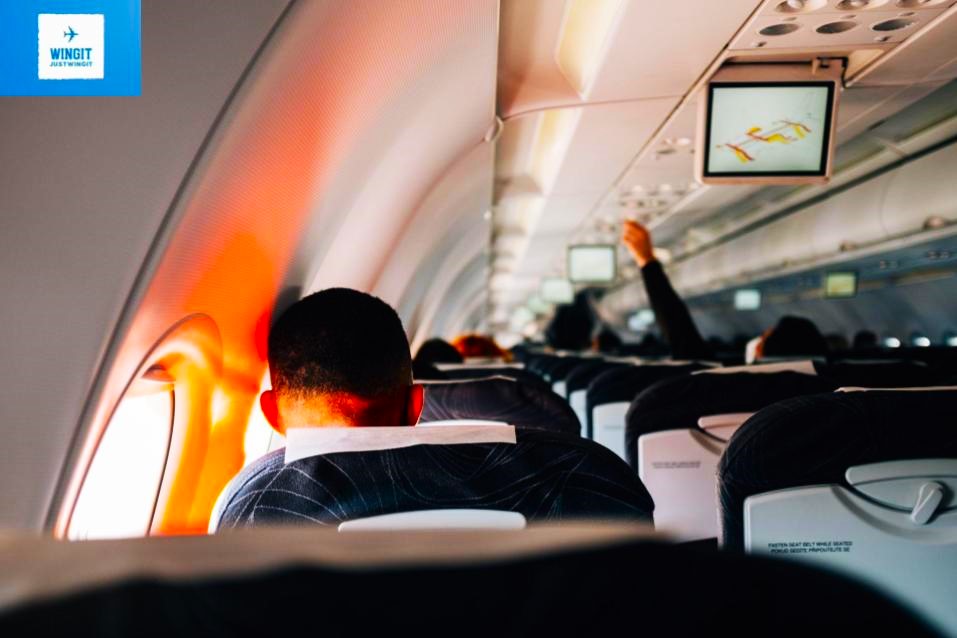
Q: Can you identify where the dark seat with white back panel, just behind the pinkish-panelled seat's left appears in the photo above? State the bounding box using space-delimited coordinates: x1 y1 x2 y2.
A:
585 362 706 450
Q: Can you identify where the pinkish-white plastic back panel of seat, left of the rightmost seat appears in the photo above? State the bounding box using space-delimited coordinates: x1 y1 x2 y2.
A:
638 412 752 541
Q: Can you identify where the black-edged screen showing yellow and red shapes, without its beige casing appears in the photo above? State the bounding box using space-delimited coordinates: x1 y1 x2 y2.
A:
705 82 834 177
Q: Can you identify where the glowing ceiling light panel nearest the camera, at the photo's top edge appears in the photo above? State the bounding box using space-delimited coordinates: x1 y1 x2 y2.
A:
555 0 625 98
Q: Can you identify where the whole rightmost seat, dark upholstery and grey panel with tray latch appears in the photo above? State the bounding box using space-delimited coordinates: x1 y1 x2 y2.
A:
719 390 957 635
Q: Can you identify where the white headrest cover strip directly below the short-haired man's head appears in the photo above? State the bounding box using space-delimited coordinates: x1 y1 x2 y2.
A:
285 425 515 463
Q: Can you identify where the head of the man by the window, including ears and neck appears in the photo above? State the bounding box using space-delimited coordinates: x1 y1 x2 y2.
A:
260 288 421 433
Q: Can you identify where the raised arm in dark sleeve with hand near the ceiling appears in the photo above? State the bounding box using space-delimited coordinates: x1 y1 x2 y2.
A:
621 220 713 359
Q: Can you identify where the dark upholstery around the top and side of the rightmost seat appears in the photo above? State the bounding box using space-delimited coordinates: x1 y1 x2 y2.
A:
718 391 957 550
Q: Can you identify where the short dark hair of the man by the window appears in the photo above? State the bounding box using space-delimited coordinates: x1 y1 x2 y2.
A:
269 288 412 398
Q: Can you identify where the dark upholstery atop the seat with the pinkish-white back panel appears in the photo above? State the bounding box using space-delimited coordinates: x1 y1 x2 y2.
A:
625 372 838 471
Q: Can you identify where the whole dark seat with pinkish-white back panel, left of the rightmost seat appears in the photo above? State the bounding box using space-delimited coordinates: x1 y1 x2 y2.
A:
624 364 835 541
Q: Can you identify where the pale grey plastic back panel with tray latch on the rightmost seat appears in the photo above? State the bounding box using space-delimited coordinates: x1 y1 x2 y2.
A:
744 459 957 635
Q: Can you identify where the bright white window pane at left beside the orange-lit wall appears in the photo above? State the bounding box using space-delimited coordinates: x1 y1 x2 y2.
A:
67 382 175 540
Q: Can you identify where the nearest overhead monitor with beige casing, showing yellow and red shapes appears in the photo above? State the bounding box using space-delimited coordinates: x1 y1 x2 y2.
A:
698 63 840 184
